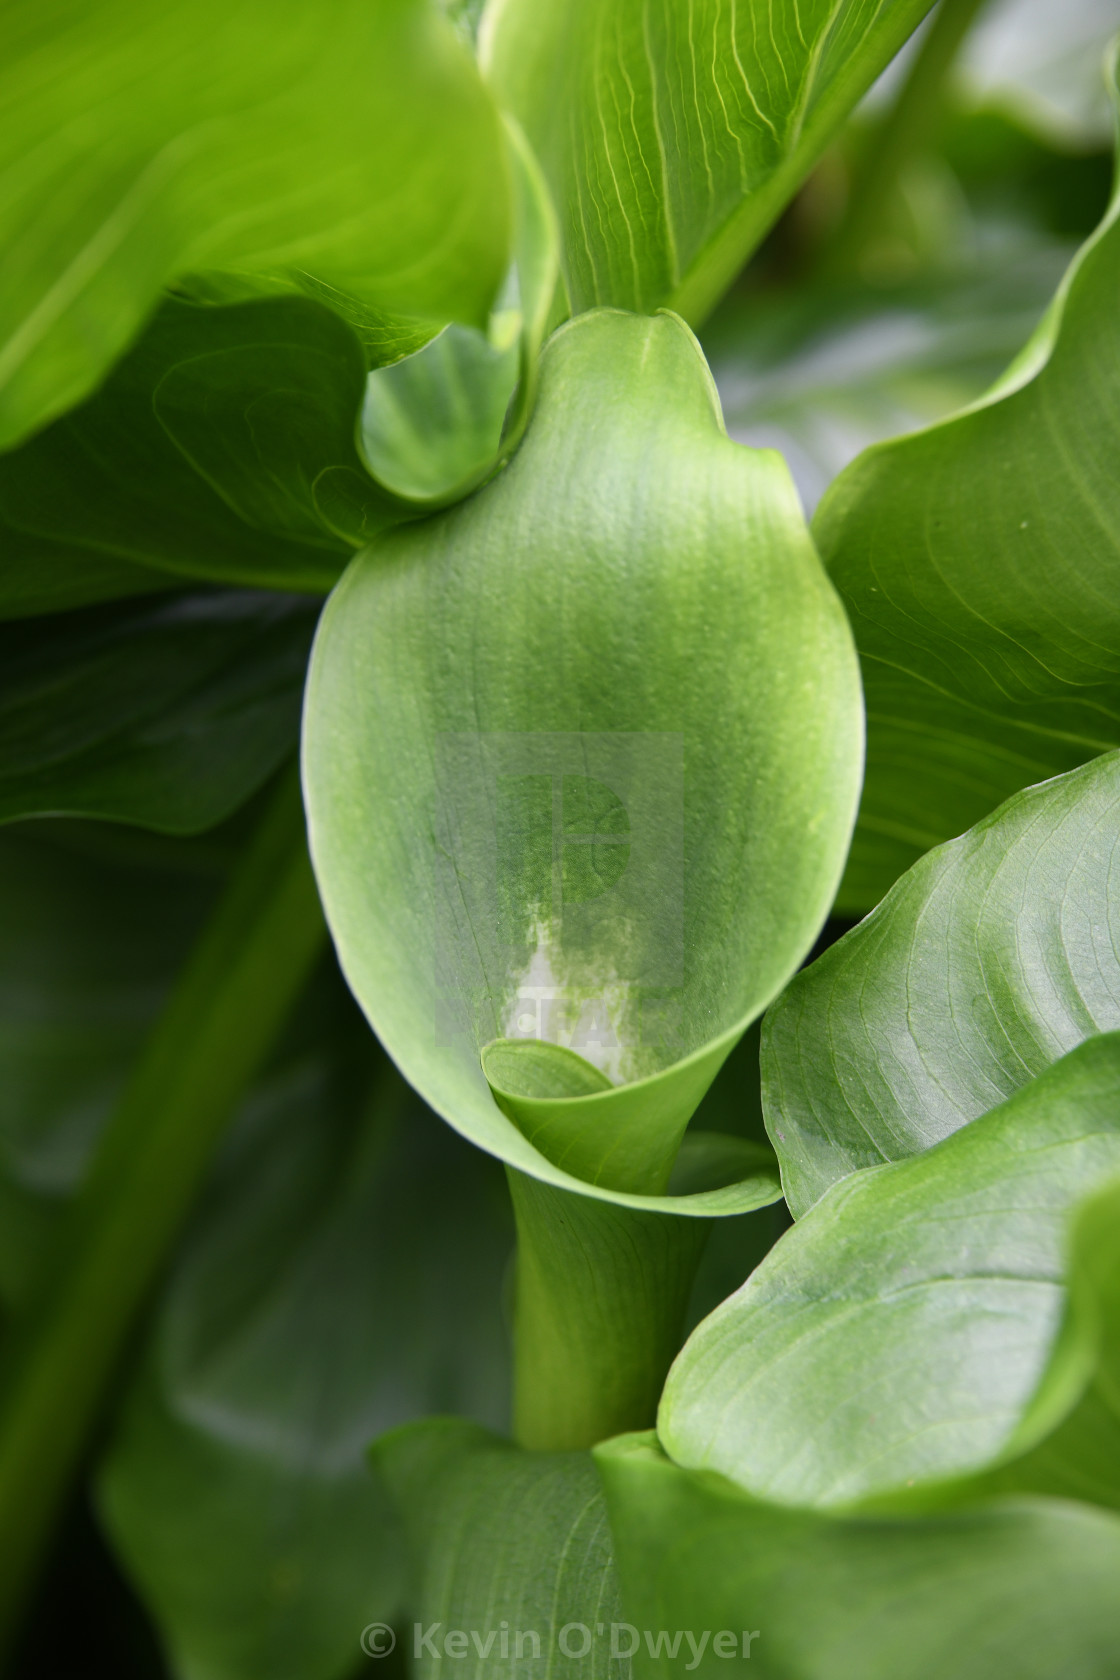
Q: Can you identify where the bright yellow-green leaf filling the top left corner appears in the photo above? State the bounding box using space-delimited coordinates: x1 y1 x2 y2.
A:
0 0 509 447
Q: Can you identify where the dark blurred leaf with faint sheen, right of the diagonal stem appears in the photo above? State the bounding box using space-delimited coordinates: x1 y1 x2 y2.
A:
97 1041 512 1680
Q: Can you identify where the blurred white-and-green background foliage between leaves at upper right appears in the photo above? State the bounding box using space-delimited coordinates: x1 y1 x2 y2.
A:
702 0 1117 512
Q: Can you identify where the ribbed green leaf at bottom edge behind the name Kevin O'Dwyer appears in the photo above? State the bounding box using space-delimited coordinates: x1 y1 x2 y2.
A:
373 1418 621 1680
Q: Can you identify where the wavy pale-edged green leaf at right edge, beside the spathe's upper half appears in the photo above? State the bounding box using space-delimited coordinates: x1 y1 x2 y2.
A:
814 59 1120 909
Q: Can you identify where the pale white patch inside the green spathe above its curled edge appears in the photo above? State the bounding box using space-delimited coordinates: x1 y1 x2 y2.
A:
502 919 638 1085
